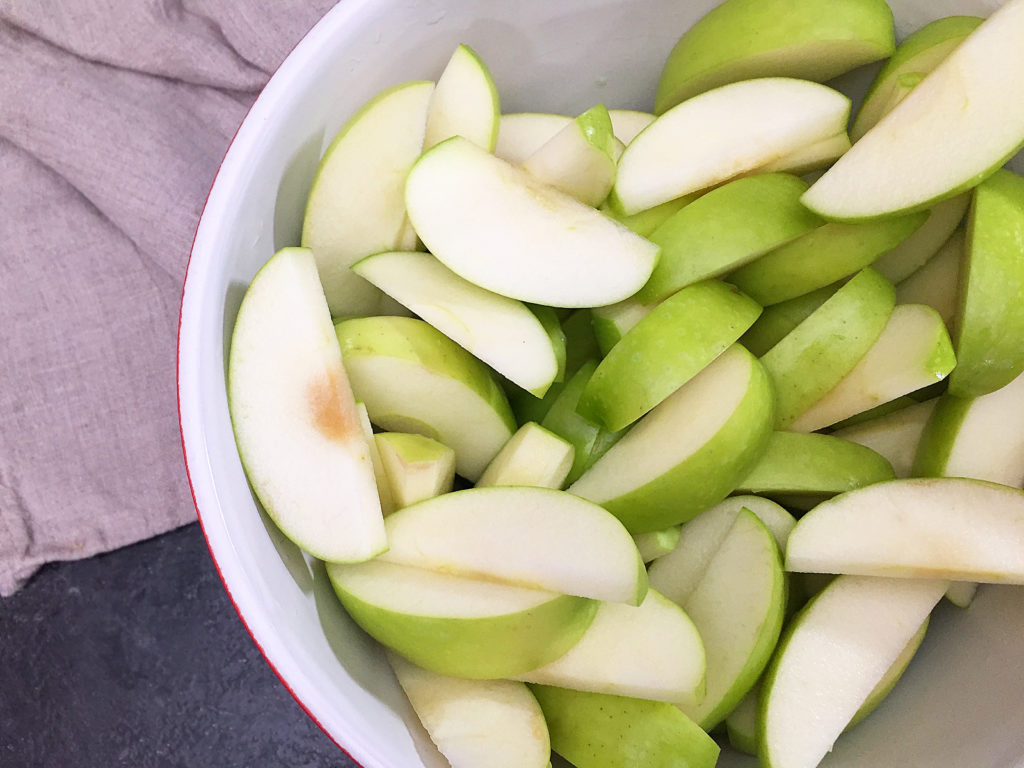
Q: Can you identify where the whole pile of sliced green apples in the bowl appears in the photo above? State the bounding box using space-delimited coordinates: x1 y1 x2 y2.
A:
228 0 1024 768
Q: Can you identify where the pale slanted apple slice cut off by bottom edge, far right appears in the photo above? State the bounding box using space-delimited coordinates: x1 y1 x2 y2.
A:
759 577 948 768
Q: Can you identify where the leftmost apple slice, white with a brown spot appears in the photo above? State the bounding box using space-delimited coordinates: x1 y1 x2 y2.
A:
227 248 387 561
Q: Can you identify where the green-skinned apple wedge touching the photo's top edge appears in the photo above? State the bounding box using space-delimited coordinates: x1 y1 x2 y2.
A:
654 0 896 114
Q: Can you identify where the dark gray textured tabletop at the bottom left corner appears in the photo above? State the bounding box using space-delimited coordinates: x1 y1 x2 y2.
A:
0 524 355 768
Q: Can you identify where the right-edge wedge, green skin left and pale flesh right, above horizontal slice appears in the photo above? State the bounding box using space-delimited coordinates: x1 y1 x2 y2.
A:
913 375 1024 487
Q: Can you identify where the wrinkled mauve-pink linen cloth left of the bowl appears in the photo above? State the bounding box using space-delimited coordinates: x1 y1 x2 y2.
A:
0 0 333 595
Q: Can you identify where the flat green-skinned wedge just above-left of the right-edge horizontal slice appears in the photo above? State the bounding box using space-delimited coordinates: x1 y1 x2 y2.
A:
738 432 895 496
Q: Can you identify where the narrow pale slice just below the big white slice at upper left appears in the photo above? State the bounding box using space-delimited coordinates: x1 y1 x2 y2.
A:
352 251 564 397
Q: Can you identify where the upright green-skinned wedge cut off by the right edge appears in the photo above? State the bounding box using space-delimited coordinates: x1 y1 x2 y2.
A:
949 169 1024 397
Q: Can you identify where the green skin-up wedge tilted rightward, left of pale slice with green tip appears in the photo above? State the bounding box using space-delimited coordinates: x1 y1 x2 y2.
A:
761 268 896 429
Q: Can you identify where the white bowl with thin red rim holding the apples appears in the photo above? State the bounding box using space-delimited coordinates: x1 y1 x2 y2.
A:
178 0 1024 768
